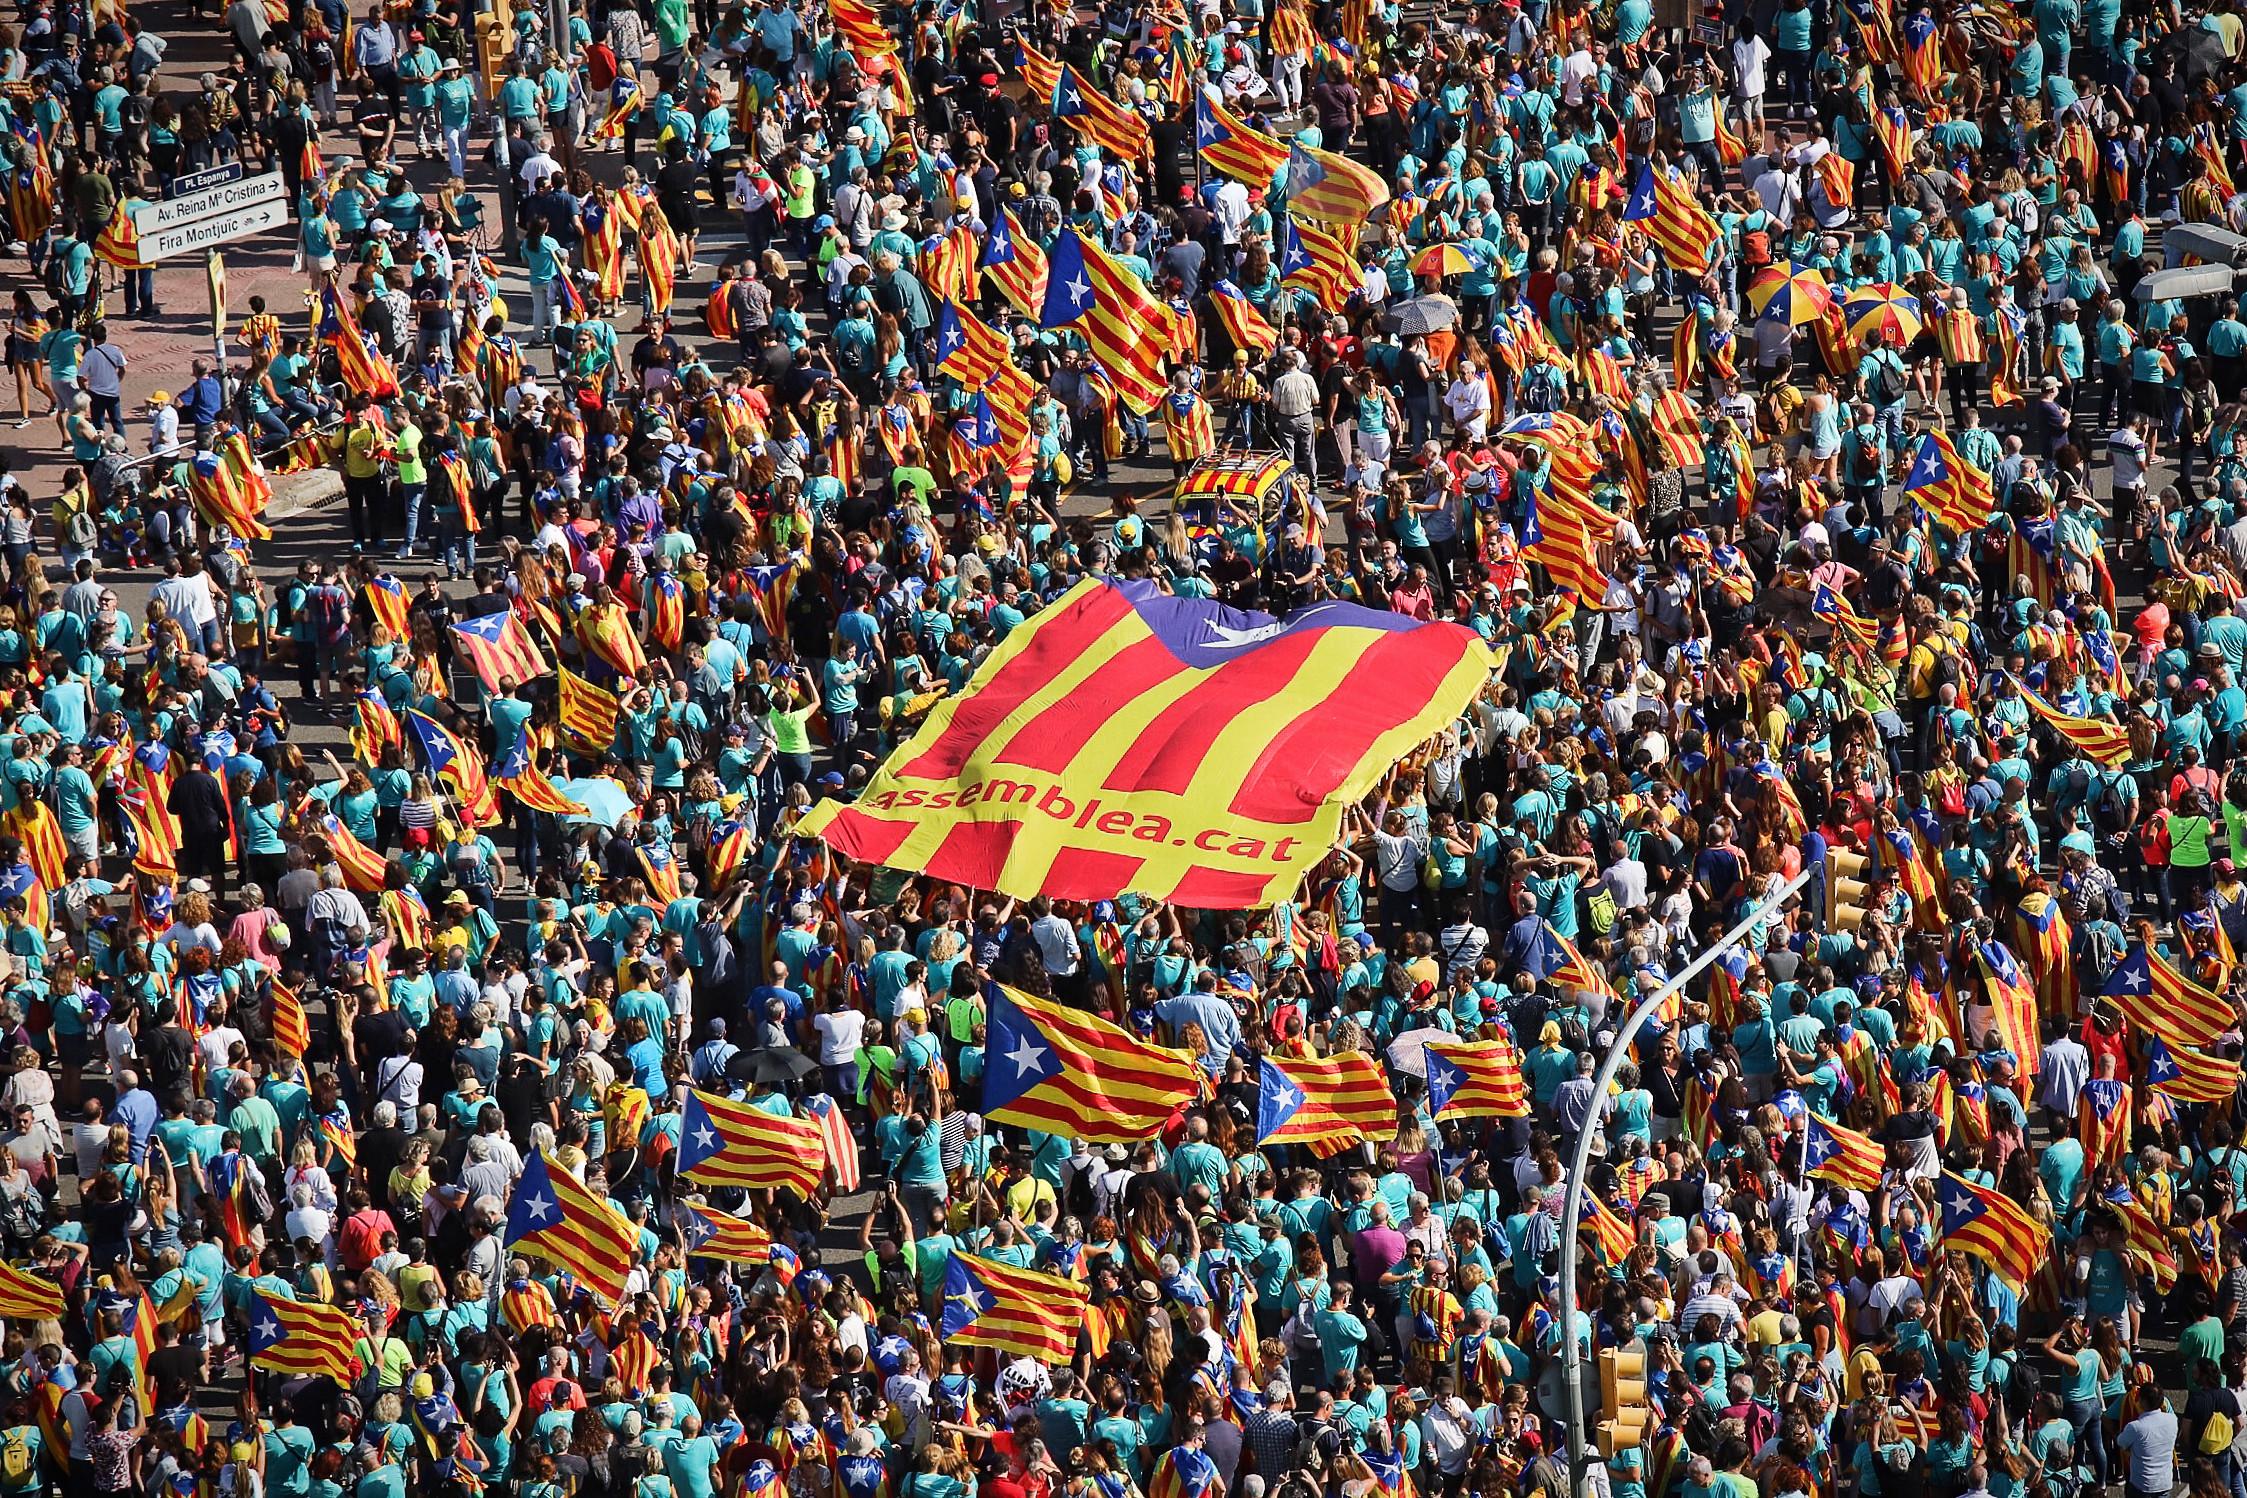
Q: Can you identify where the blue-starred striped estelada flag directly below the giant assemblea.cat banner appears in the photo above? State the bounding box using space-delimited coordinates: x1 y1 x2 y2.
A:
984 986 1202 1143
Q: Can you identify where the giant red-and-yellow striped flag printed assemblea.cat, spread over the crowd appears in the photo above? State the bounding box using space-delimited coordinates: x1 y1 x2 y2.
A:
798 577 1490 910
